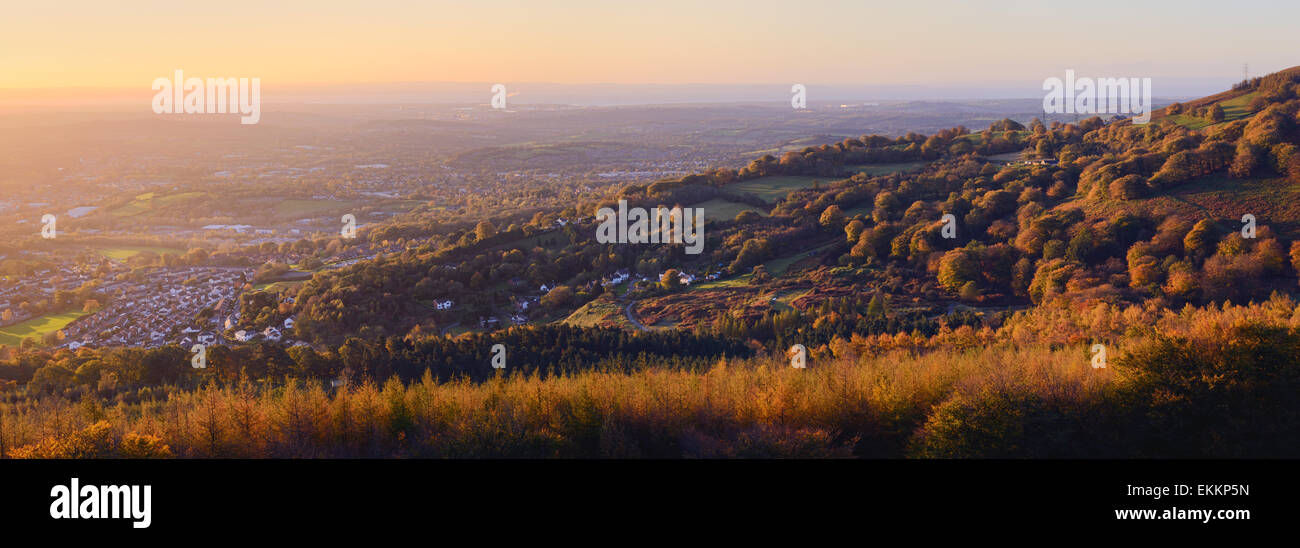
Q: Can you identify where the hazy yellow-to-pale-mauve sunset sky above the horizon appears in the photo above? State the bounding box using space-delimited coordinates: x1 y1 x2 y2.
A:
0 0 1300 90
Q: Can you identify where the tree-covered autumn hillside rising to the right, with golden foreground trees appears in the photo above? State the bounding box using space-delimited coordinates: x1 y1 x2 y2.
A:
0 64 1300 457
